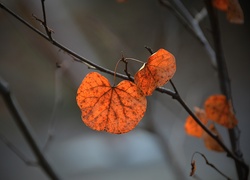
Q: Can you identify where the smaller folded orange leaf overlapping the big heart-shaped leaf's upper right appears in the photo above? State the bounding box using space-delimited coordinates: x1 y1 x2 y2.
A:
135 49 176 96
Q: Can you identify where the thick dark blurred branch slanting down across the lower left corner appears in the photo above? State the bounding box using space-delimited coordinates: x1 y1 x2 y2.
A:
0 77 59 180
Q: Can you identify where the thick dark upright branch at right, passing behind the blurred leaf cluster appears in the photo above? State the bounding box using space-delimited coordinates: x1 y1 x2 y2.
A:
205 0 249 180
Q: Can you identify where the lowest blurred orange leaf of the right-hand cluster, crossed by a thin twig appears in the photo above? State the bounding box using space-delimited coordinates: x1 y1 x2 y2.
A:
203 124 224 152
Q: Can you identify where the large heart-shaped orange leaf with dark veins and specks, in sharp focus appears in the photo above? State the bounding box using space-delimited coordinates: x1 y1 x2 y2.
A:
76 72 147 134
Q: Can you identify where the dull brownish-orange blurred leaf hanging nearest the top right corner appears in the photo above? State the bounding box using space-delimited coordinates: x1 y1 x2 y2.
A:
227 0 244 24
